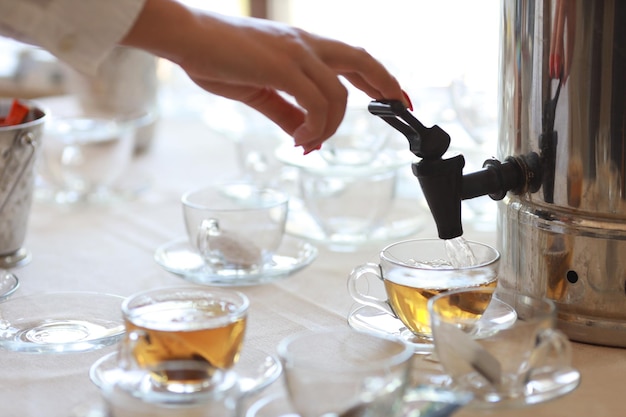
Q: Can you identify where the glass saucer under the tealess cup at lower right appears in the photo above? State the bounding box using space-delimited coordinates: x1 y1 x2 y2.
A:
468 366 580 410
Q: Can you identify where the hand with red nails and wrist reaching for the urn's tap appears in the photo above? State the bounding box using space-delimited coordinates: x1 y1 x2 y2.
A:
124 0 409 152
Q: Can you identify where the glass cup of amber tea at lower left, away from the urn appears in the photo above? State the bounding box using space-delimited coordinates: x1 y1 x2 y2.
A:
120 287 250 392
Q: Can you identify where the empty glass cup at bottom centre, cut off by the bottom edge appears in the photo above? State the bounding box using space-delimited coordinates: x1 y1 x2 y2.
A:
278 329 413 417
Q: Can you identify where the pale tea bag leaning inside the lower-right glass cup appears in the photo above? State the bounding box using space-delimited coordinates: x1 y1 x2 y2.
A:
442 324 502 386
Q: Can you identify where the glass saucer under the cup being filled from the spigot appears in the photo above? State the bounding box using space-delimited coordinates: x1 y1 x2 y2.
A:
348 298 517 353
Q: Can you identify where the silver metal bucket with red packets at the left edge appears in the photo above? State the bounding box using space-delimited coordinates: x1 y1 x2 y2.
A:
0 99 46 269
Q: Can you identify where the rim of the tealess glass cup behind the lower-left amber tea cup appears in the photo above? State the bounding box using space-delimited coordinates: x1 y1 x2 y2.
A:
181 182 289 211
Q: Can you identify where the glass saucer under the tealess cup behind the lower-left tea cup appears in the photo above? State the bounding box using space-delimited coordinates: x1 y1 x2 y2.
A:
154 236 318 286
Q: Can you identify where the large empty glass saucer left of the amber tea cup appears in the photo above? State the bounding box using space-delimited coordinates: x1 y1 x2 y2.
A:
0 291 124 353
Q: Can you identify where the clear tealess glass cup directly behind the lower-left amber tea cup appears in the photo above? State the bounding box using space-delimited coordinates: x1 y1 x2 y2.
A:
182 183 289 276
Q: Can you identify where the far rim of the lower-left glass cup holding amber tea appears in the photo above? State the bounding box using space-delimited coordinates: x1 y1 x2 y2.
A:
121 286 250 321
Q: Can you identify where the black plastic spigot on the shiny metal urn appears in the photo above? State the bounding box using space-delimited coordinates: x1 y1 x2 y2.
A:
368 101 542 239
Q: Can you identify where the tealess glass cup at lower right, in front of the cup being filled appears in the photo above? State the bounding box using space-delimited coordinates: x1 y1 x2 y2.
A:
428 288 580 406
